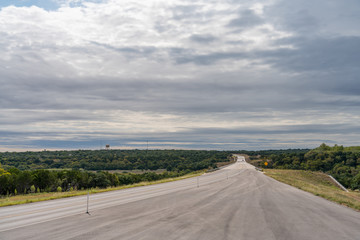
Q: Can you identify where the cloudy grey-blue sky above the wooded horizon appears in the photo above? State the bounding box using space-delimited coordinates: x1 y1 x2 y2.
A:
0 0 360 151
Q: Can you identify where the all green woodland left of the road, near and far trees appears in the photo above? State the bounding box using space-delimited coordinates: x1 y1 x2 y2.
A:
0 150 233 196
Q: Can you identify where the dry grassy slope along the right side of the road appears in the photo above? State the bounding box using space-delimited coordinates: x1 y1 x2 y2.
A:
264 169 360 211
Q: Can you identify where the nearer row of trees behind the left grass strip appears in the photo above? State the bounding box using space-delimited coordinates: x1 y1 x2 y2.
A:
0 166 190 196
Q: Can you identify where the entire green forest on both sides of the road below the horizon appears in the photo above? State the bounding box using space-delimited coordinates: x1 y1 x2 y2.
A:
0 144 360 195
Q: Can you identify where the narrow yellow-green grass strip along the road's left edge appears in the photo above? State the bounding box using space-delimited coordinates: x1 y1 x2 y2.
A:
0 171 205 207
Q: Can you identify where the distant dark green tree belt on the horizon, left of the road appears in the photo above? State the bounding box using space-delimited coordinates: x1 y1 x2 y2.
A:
0 150 231 171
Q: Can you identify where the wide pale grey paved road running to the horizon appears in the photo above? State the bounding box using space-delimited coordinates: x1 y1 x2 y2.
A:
0 156 360 240
